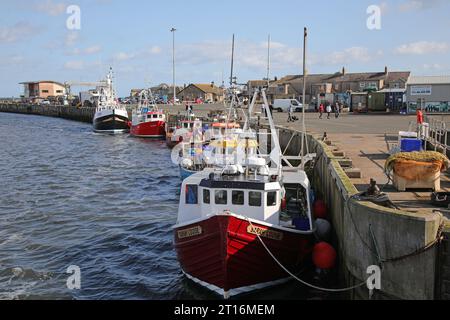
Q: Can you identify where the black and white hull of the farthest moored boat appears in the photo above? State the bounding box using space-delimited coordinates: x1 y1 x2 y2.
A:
93 109 130 134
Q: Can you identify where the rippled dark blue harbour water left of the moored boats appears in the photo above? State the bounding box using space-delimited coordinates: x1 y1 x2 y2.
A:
0 113 312 299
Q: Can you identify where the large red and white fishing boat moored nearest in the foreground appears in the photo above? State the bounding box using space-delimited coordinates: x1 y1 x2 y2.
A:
174 91 314 298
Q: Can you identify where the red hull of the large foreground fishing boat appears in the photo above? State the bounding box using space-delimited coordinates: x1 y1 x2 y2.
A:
174 215 312 293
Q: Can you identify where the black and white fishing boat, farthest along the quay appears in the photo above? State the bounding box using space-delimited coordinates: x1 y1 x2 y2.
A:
93 69 130 134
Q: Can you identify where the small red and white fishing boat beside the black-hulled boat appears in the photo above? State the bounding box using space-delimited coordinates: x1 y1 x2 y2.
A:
131 90 166 138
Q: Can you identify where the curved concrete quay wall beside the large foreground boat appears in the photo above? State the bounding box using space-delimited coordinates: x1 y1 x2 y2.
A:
280 128 450 300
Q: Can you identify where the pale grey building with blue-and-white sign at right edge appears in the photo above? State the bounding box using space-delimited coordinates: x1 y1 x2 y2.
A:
406 76 450 113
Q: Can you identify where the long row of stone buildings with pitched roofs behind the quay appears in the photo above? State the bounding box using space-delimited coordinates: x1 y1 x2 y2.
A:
268 67 410 105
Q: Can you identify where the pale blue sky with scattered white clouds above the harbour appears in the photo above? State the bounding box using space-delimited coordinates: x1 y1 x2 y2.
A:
0 0 450 97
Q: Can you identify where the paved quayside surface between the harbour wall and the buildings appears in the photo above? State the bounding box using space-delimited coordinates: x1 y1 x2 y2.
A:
274 114 450 218
